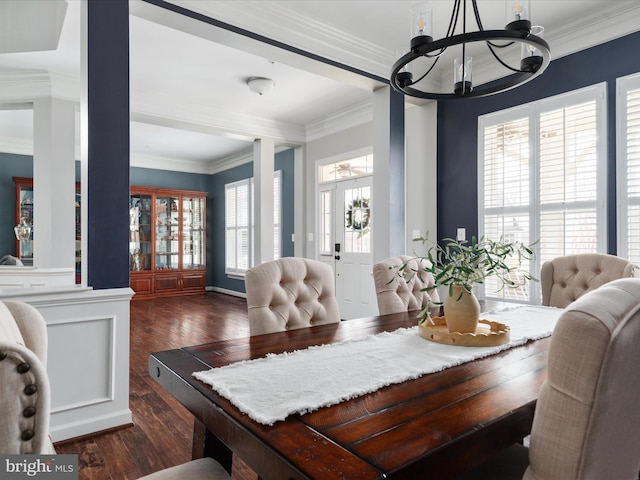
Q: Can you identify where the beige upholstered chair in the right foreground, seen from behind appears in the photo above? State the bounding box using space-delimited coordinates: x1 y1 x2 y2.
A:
462 278 640 480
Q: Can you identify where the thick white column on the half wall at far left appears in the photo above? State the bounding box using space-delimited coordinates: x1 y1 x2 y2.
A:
33 98 76 276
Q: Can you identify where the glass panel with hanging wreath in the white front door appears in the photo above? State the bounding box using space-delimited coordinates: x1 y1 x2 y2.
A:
344 186 371 253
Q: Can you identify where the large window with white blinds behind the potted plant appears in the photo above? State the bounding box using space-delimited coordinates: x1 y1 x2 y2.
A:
478 84 606 303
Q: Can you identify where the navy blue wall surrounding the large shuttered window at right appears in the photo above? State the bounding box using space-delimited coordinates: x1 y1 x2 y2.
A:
438 33 640 254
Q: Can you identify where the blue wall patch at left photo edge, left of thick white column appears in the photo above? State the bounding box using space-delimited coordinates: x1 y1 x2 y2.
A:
0 153 33 257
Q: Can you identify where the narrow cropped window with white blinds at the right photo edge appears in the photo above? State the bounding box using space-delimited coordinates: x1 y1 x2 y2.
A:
616 74 640 263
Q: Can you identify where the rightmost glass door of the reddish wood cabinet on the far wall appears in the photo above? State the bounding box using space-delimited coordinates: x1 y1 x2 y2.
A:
182 197 205 269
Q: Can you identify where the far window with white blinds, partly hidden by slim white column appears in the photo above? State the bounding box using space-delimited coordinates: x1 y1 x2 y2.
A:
225 170 282 275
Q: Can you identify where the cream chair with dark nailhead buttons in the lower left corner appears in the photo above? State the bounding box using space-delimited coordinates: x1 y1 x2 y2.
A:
0 301 231 480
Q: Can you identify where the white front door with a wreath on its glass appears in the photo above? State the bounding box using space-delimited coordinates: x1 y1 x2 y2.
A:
333 176 378 319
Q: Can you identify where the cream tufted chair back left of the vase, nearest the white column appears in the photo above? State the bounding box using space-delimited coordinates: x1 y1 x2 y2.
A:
244 257 340 335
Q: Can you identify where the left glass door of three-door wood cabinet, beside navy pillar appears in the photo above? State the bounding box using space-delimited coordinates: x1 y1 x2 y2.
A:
129 194 152 272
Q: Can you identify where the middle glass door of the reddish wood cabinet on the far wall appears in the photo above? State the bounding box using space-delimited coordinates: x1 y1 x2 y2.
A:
155 196 180 270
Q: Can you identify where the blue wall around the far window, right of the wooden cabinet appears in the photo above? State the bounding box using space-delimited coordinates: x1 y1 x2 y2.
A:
207 150 294 292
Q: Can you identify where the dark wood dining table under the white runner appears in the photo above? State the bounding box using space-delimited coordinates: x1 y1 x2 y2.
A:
149 312 550 480
